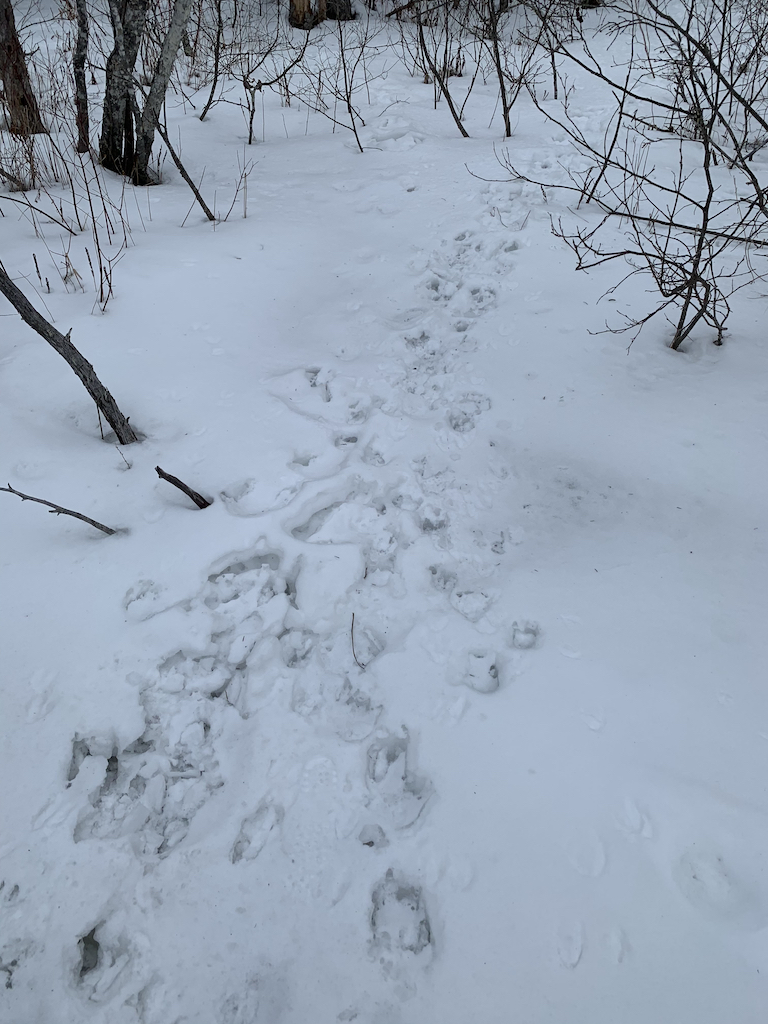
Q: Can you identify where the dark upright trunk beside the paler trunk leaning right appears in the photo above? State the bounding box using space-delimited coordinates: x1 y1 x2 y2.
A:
99 0 148 175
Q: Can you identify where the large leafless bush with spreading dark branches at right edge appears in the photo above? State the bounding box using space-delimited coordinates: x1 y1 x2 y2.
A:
505 0 768 349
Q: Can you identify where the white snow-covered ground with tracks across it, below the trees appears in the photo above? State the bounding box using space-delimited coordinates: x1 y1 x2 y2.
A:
0 16 768 1024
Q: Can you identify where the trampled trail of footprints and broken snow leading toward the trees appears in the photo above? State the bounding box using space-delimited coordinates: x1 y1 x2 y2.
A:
45 163 540 1021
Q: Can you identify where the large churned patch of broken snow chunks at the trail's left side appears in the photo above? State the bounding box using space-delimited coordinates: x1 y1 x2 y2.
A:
68 549 290 858
